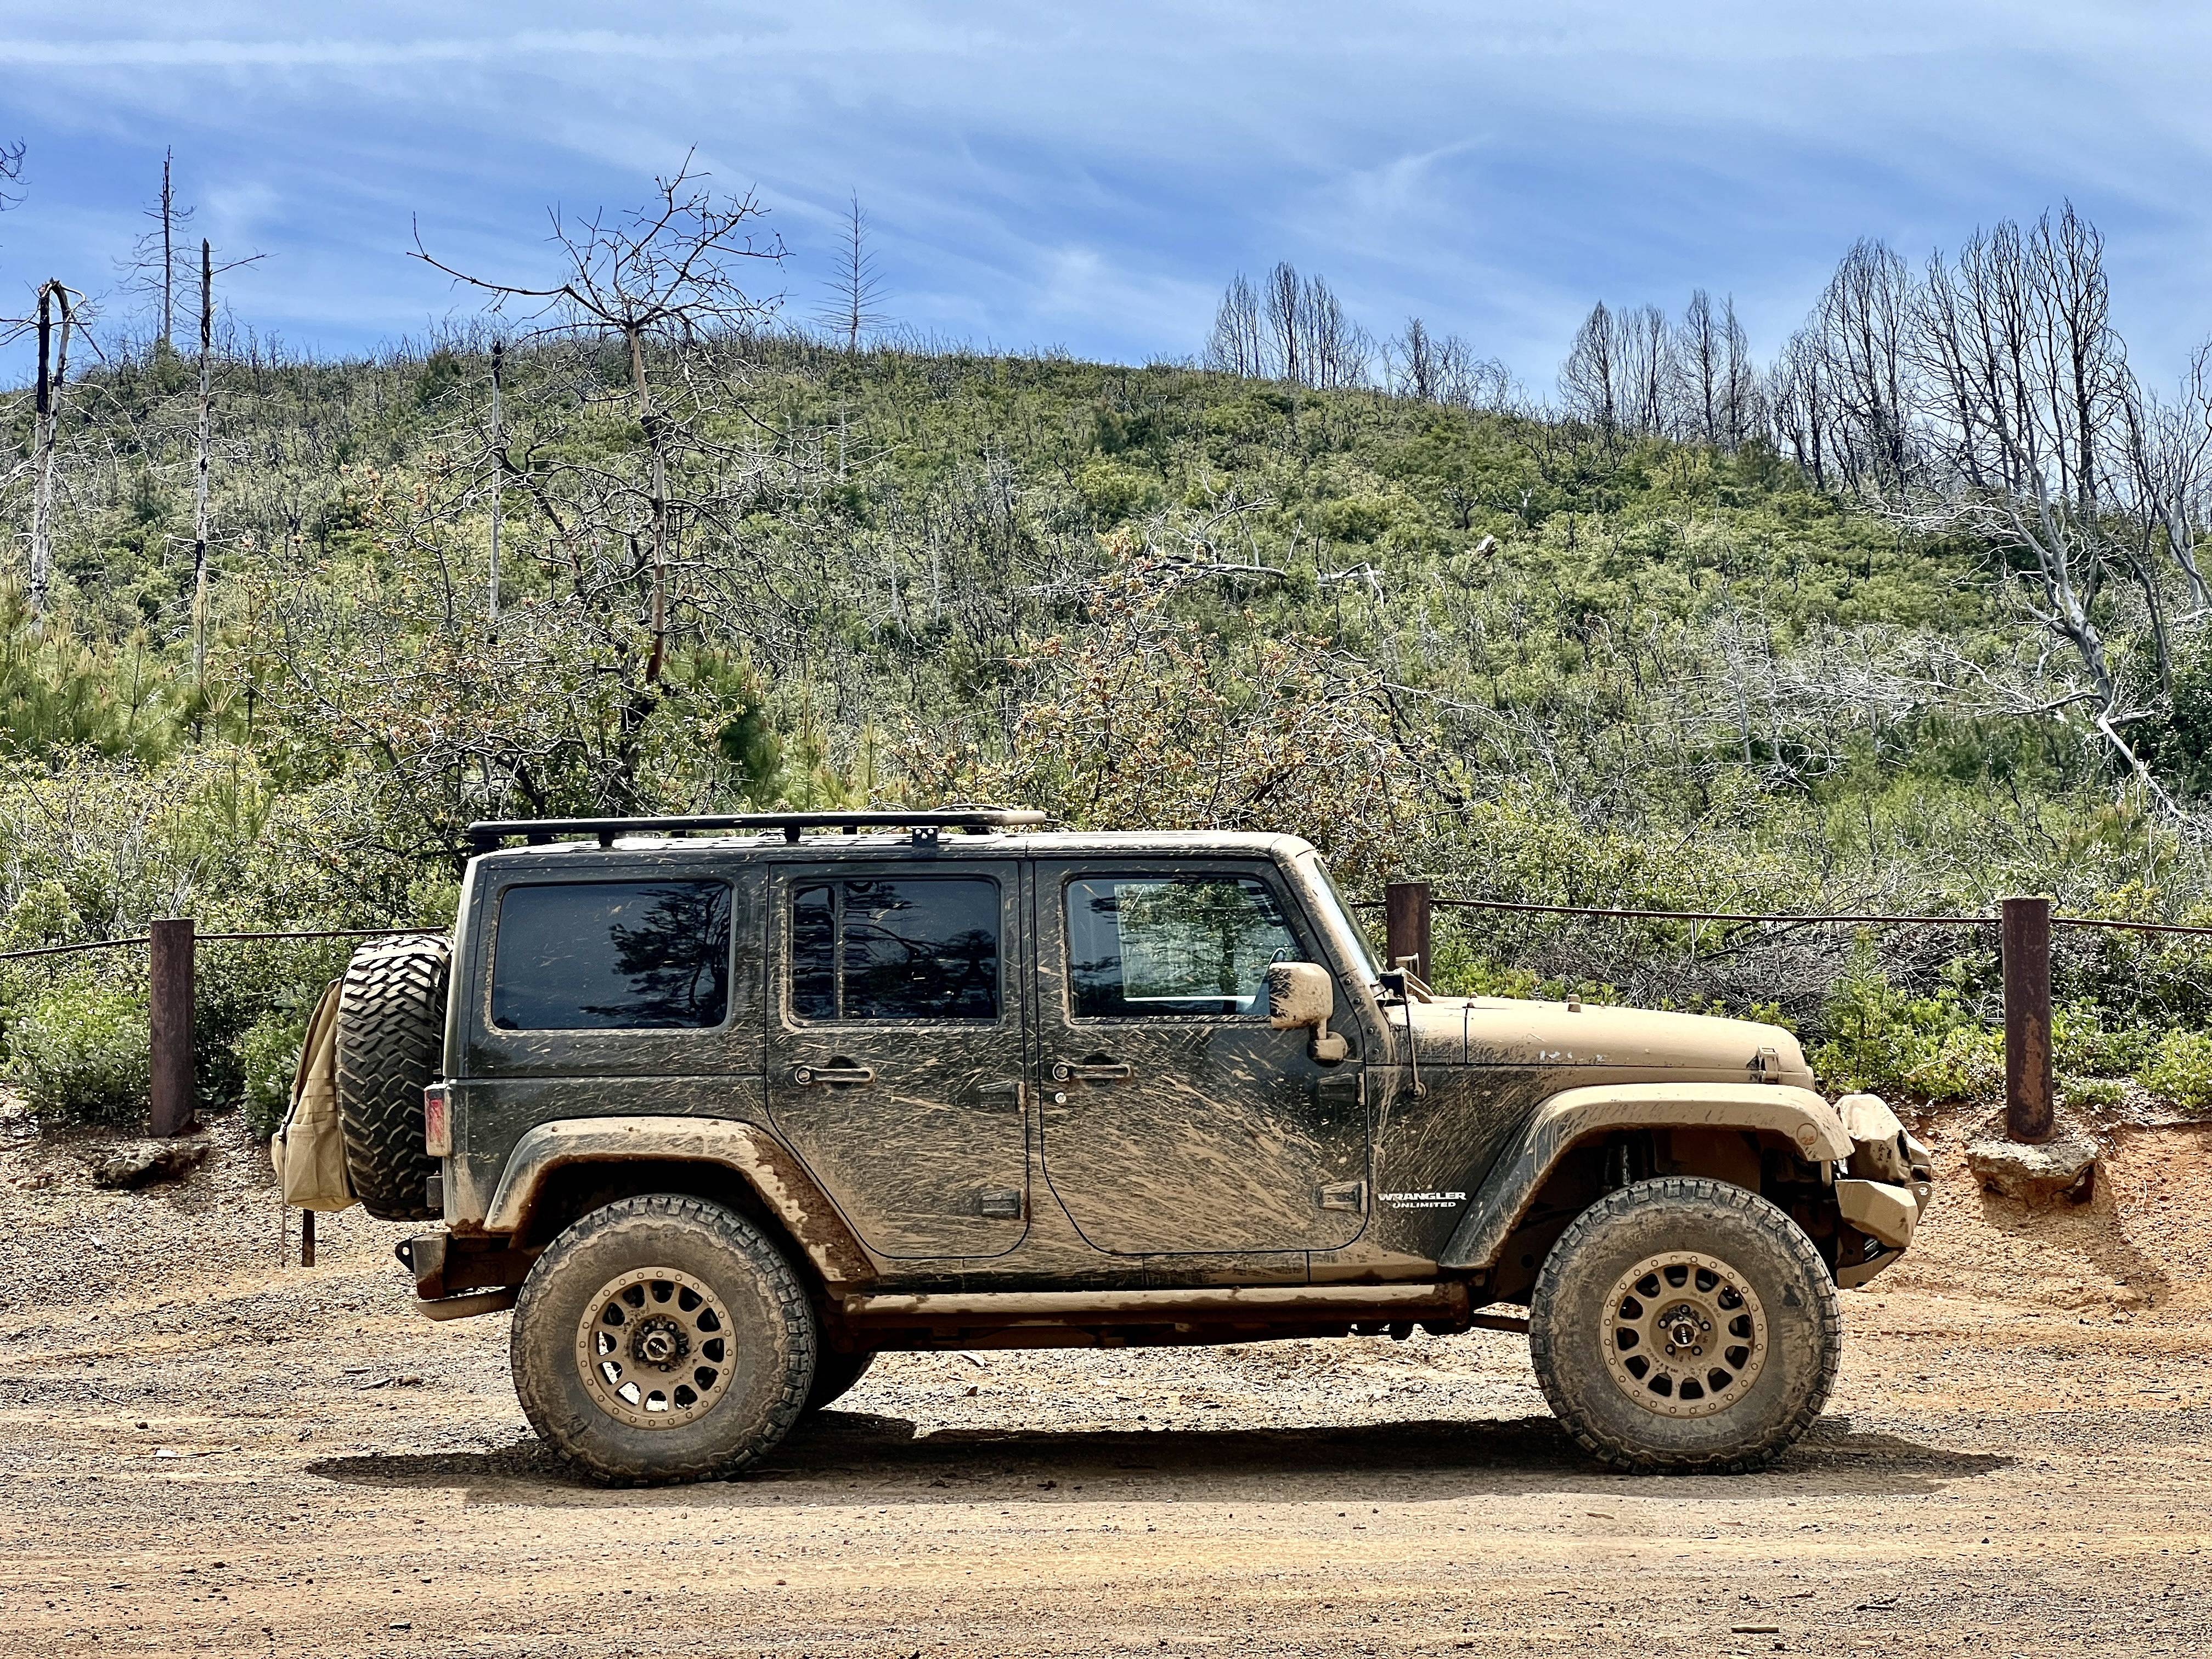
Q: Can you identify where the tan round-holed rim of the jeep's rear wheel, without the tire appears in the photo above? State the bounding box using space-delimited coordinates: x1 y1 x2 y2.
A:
575 1267 732 1429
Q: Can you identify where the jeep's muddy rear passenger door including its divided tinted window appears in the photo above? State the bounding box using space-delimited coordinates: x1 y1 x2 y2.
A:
768 858 1029 1256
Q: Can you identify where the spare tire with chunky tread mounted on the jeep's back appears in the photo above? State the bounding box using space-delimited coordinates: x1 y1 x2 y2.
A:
338 938 452 1221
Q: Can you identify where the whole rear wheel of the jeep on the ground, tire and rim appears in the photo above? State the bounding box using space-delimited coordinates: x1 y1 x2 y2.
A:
511 1192 819 1487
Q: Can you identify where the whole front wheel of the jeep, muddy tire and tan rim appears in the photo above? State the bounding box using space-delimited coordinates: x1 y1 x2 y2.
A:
1528 1177 1843 1473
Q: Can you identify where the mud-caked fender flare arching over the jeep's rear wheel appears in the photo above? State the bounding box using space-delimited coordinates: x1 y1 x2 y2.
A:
484 1117 876 1288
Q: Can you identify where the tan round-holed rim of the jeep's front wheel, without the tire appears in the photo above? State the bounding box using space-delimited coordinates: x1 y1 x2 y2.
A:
1604 1250 1768 1418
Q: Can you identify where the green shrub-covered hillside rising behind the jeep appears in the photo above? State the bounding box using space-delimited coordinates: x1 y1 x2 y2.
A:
0 336 2212 1113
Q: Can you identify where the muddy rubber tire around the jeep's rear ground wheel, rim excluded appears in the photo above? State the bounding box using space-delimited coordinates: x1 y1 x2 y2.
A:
509 1192 819 1487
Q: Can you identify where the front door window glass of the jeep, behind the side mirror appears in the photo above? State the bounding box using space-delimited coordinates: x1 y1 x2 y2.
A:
1068 876 1305 1020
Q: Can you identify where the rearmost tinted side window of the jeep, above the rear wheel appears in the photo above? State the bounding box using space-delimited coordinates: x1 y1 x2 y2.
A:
491 881 730 1031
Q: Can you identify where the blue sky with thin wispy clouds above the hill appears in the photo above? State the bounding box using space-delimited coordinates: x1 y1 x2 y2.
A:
0 0 2212 394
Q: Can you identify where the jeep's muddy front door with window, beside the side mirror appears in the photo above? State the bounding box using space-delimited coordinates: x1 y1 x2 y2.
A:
1035 862 1367 1254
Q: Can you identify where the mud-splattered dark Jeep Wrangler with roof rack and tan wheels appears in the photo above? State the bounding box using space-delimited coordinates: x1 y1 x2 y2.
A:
338 812 1929 1482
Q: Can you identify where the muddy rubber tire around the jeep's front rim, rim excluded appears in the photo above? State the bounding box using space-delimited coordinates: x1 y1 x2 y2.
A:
1528 1175 1843 1475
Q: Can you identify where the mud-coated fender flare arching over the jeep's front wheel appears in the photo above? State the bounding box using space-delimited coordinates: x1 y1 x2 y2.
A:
1440 1084 1852 1267
